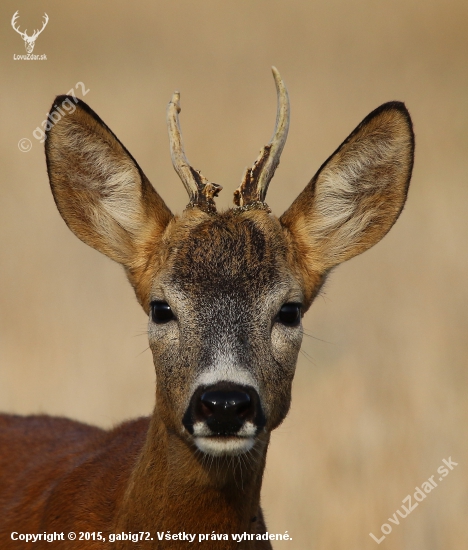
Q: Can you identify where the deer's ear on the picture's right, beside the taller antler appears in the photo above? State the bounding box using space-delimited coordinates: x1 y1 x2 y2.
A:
280 102 414 296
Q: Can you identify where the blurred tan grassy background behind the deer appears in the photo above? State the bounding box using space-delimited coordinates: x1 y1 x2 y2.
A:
0 0 468 550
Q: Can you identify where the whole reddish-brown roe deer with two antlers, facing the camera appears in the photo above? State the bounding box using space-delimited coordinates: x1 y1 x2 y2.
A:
0 68 414 550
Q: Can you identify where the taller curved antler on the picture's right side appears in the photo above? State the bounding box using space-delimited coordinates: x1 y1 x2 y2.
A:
234 67 290 208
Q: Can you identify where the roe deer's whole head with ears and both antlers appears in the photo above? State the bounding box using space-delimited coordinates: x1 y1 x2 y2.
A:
46 69 414 464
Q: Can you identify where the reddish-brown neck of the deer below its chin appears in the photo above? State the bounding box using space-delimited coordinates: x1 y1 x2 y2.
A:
116 409 269 550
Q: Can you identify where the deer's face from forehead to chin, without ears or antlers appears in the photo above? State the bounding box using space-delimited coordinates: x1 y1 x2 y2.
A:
149 209 304 455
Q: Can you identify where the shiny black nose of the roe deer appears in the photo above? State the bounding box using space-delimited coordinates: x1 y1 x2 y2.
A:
183 382 265 436
